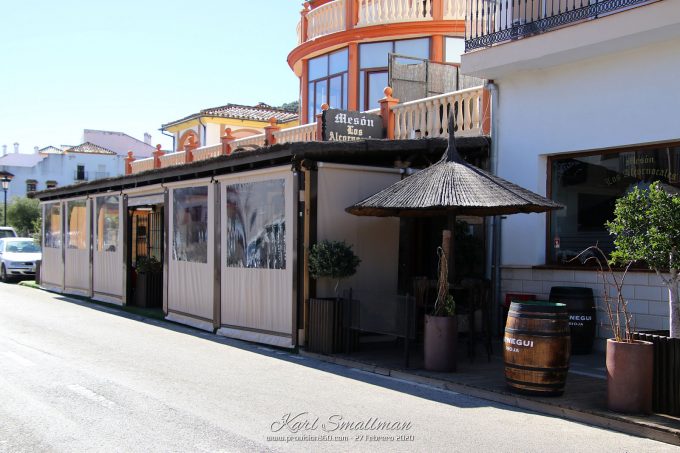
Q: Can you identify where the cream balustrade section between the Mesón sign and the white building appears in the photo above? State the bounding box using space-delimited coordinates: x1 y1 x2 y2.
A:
392 87 485 139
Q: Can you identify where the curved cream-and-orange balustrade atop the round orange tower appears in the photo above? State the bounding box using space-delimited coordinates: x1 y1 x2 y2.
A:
297 0 466 44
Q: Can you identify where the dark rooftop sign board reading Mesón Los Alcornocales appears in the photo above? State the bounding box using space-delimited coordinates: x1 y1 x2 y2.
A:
322 109 384 142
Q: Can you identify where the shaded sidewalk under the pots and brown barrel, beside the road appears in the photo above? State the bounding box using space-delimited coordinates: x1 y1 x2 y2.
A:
300 344 680 446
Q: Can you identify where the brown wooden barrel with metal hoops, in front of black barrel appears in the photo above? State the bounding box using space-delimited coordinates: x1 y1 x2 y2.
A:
503 301 571 396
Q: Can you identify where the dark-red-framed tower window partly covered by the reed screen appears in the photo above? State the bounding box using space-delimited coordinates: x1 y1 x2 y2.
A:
359 38 430 110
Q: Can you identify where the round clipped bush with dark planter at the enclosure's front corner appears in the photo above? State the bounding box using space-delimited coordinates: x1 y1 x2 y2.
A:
307 240 361 354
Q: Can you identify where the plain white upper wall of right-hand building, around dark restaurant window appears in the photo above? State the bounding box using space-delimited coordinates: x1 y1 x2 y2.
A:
495 39 680 265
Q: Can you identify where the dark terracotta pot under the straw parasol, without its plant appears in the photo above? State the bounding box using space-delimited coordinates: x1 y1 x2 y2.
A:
425 315 458 371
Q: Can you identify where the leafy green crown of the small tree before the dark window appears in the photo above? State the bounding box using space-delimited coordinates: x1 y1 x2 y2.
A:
607 181 680 271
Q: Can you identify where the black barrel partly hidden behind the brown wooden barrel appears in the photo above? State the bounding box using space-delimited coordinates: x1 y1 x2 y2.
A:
550 286 597 354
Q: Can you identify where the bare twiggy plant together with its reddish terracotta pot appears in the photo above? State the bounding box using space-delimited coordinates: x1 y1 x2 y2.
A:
579 245 654 414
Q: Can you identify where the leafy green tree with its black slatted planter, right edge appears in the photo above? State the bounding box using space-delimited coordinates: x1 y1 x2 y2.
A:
607 181 680 415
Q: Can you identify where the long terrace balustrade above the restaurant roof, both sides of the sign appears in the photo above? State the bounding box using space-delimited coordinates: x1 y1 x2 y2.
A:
126 86 490 174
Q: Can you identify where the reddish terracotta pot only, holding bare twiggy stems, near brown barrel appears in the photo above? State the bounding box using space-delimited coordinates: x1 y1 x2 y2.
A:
607 339 654 414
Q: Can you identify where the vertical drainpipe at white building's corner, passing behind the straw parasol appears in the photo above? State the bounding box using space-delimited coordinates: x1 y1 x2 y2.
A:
485 80 502 336
